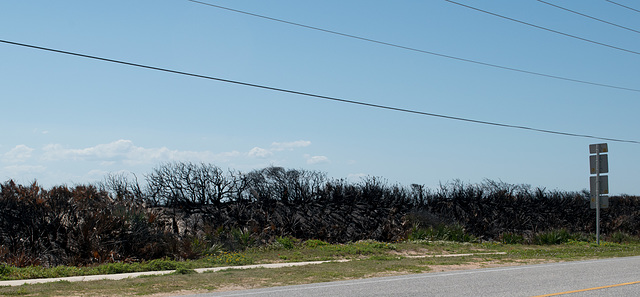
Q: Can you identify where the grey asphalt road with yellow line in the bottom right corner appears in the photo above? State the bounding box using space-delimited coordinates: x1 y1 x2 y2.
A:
184 257 640 297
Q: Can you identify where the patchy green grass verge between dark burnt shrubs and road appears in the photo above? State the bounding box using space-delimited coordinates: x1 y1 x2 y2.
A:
0 241 640 296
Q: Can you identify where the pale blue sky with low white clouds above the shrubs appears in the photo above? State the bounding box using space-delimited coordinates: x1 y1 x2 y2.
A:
0 0 640 195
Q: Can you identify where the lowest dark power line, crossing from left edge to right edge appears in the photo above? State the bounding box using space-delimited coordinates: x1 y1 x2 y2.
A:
0 39 640 144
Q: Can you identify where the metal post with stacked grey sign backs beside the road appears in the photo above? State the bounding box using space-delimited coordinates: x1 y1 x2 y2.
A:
589 143 609 245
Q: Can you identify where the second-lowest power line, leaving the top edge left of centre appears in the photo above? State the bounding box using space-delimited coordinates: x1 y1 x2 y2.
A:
187 0 640 92
